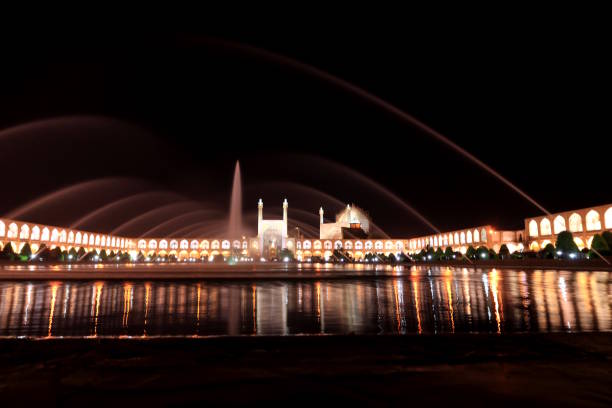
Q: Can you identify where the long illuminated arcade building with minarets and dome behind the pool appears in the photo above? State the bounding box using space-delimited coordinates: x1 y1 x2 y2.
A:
0 199 612 260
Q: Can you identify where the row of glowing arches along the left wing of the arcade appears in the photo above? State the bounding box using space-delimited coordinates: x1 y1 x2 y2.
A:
0 220 131 249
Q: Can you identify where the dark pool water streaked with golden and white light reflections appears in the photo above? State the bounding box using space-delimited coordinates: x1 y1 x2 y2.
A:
0 268 612 338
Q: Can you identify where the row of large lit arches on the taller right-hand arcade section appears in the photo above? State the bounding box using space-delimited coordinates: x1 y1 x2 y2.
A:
528 207 612 238
